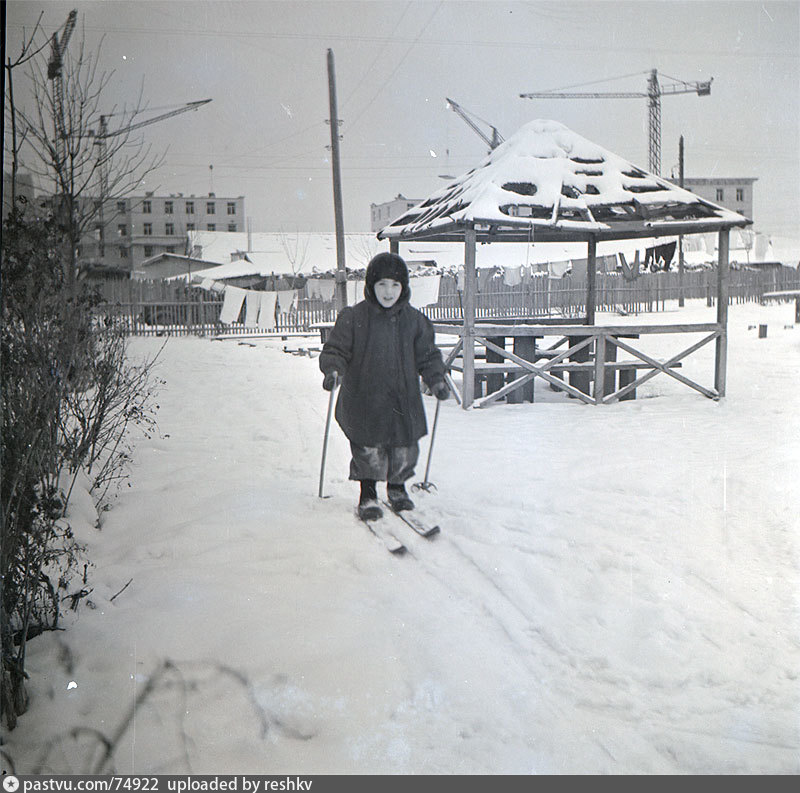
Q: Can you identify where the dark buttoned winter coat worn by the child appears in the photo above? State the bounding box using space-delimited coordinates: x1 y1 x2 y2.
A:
319 287 444 446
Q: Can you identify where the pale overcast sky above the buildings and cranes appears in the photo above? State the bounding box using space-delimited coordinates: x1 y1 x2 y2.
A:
7 0 800 254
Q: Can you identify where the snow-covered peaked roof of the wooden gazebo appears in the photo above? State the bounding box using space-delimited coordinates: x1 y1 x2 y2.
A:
378 120 751 242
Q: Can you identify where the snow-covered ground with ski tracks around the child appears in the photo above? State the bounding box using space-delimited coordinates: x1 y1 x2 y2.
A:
3 301 800 774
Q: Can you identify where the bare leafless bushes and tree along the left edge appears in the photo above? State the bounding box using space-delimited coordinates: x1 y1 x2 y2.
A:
0 13 166 728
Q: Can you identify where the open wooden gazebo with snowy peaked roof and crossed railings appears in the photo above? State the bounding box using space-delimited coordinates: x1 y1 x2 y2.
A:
378 120 752 408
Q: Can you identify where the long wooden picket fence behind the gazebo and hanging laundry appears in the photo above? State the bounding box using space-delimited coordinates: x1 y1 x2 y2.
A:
97 267 800 336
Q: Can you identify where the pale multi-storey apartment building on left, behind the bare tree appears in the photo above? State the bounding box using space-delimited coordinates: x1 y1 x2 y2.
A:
79 193 245 275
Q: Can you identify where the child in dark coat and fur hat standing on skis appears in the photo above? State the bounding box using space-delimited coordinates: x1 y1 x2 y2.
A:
319 253 450 520
